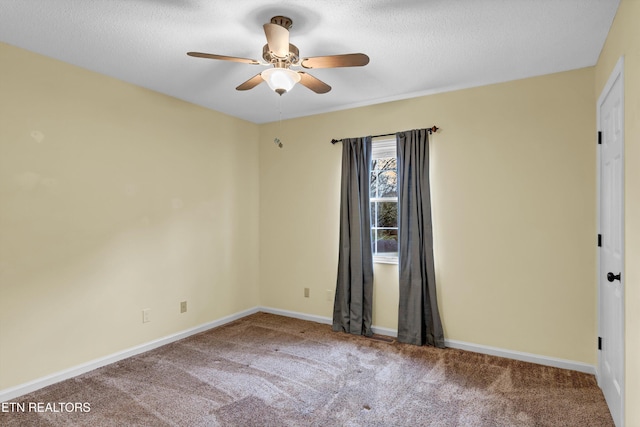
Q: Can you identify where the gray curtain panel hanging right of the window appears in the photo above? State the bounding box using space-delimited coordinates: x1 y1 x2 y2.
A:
396 129 445 348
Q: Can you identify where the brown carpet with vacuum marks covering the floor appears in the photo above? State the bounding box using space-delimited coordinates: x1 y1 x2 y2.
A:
0 313 613 427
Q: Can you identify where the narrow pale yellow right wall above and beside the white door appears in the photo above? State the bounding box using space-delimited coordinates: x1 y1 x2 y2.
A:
595 0 640 426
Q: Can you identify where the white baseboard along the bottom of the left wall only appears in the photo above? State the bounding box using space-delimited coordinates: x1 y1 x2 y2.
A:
0 307 260 402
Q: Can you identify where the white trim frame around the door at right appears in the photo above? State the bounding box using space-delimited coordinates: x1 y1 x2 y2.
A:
596 55 626 427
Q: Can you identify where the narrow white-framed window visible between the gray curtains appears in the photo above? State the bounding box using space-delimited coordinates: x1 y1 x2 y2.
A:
370 139 398 263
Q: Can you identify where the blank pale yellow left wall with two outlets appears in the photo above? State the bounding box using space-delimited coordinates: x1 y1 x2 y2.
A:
0 44 259 390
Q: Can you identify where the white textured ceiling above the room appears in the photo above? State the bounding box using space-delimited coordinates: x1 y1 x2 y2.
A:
0 0 619 123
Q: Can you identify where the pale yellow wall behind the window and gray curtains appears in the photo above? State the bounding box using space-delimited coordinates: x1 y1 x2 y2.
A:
260 68 596 364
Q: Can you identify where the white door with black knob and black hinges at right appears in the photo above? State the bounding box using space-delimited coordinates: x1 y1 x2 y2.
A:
598 58 625 426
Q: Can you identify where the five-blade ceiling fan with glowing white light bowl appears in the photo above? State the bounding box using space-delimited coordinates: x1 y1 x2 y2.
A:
187 16 369 96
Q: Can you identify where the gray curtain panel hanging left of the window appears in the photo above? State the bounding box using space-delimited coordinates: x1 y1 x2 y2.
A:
333 137 373 336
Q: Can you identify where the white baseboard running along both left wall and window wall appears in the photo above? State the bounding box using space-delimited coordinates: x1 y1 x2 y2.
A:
0 307 597 402
